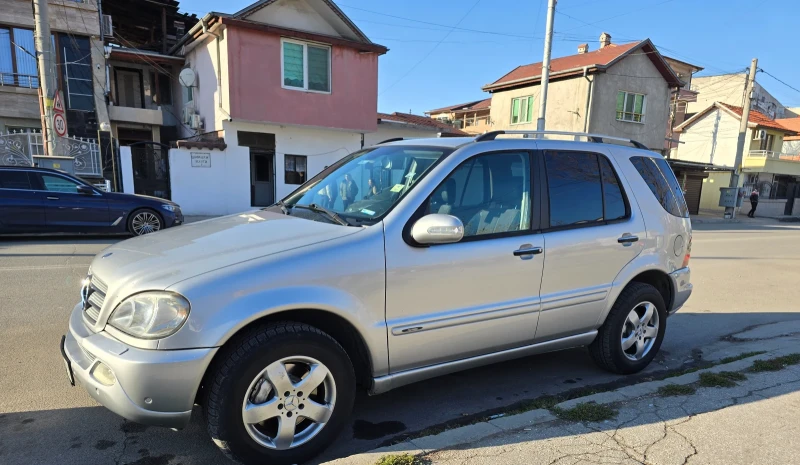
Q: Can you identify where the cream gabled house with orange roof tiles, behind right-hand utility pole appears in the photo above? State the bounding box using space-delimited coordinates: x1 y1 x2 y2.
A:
674 102 800 216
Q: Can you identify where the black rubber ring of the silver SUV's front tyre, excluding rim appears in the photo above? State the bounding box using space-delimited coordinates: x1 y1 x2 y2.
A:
215 333 355 463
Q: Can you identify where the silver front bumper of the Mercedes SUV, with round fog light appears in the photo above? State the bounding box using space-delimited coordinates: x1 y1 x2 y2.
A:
62 304 217 428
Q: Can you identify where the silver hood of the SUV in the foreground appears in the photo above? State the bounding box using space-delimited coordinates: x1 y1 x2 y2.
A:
90 210 361 294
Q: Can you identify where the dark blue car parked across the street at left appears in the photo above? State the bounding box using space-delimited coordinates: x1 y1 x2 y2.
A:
0 166 183 236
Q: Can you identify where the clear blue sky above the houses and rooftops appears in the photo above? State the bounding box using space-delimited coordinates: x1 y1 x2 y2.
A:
186 0 800 114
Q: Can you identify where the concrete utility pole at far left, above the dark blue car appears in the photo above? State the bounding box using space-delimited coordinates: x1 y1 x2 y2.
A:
33 0 58 155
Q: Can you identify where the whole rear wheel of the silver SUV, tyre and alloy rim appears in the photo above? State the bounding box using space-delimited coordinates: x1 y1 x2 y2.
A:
589 282 667 374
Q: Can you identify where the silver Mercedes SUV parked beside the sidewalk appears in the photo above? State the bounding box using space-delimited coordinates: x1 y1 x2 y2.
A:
62 131 692 464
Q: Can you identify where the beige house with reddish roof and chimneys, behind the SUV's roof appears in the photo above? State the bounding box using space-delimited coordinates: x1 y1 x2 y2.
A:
483 33 684 151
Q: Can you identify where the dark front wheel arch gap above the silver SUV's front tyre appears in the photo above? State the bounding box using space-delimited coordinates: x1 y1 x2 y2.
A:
196 308 373 403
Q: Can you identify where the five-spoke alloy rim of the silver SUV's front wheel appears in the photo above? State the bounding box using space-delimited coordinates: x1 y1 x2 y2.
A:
242 356 336 450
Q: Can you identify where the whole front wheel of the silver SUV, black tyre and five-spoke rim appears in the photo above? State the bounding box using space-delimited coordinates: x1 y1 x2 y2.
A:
204 322 356 465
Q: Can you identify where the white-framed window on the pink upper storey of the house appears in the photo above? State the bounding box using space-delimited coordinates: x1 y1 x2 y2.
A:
281 39 331 92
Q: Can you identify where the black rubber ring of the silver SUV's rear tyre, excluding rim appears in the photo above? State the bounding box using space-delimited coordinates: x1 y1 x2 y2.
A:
608 285 667 373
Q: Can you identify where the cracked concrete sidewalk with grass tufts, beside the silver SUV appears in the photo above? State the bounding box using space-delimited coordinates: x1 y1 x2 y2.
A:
329 320 800 465
